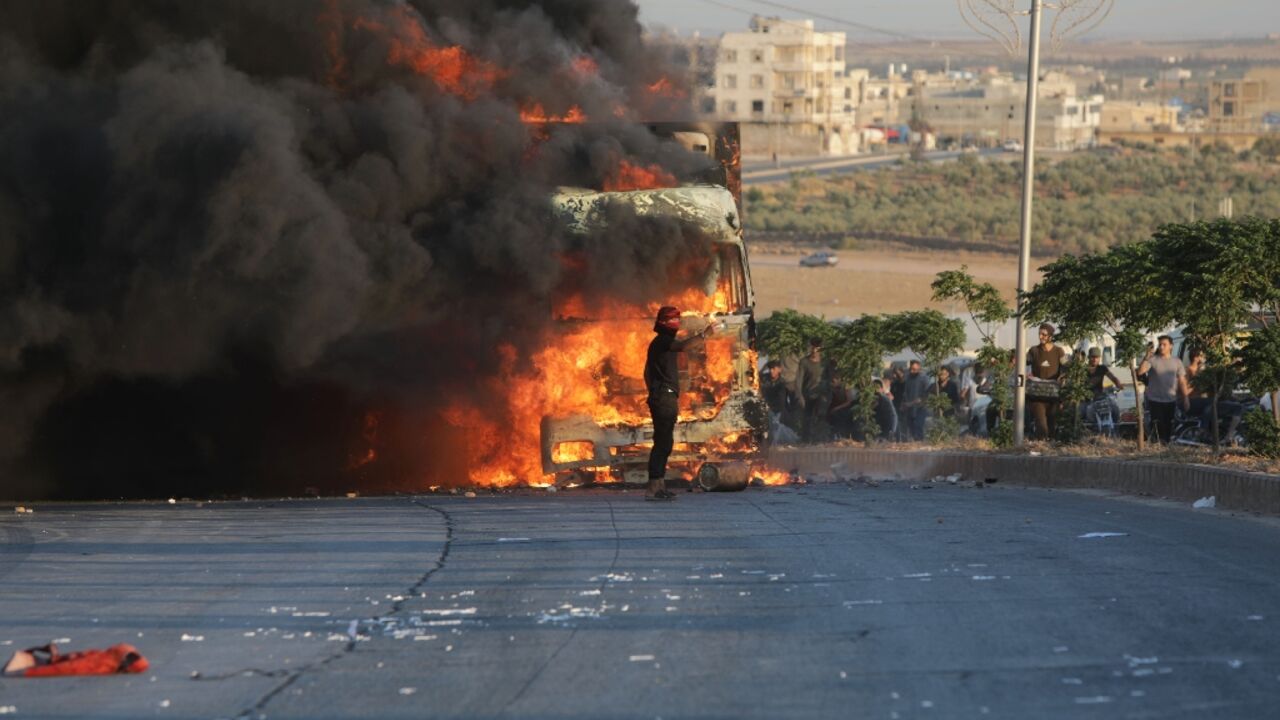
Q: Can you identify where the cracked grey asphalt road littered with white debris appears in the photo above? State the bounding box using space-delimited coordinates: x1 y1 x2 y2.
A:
0 482 1280 719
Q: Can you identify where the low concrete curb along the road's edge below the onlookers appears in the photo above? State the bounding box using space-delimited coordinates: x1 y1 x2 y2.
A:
768 447 1280 514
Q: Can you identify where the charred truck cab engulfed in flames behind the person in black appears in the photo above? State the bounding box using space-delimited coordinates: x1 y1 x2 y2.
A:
540 123 767 489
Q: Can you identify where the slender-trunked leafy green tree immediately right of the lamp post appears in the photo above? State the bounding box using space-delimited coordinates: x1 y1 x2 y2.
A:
1023 242 1172 448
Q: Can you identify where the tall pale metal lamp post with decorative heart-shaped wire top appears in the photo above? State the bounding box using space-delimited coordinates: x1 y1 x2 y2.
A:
956 0 1115 447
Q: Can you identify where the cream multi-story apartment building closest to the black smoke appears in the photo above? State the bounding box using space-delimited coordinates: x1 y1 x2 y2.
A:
712 17 858 155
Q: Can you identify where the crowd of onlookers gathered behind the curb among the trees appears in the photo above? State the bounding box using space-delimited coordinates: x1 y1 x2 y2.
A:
760 323 1244 443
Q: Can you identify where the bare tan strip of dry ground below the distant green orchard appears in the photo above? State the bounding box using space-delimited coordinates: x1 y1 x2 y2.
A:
750 246 1043 318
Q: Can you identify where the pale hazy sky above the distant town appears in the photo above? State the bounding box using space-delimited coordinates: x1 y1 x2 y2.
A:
635 0 1280 40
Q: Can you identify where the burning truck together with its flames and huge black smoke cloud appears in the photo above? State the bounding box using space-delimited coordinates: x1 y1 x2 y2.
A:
0 0 783 497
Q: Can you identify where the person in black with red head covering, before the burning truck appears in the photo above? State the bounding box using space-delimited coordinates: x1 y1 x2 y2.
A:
644 305 712 500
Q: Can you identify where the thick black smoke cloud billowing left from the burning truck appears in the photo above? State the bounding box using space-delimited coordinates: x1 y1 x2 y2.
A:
0 0 707 496
